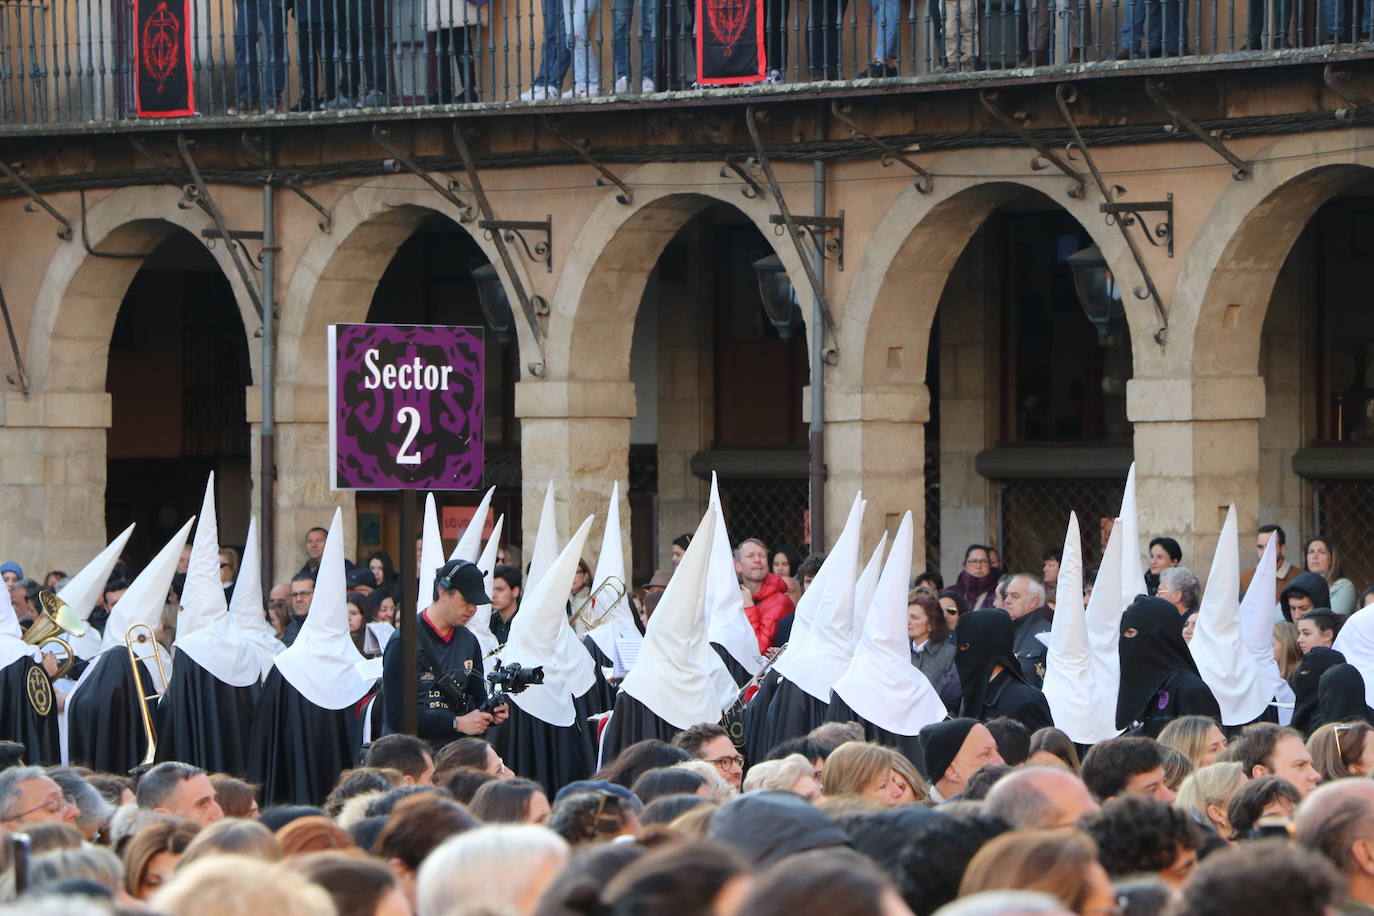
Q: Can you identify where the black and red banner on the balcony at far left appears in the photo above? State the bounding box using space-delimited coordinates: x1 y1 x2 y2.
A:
133 0 195 118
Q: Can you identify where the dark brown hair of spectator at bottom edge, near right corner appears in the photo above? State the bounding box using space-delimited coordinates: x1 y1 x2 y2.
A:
1178 839 1345 916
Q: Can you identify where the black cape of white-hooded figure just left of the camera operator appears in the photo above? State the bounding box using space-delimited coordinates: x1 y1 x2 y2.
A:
249 667 359 808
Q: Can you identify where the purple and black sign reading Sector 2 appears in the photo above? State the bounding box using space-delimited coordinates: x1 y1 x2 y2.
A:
330 324 484 490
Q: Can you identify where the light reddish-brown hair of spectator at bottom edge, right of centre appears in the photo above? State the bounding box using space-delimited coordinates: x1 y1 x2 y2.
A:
959 829 1116 916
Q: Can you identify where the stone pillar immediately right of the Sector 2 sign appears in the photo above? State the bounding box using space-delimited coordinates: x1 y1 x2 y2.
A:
515 379 635 564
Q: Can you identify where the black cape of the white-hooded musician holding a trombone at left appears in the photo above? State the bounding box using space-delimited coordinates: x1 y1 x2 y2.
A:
67 648 157 773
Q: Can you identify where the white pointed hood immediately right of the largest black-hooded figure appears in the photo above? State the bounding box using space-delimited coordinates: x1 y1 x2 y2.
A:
1189 505 1274 725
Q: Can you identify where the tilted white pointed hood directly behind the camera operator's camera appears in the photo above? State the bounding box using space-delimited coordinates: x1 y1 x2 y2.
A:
500 515 596 728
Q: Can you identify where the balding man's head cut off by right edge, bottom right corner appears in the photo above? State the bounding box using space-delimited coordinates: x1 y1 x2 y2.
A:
1293 779 1374 913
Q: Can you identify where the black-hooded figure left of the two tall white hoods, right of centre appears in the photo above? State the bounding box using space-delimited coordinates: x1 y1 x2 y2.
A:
954 607 1049 732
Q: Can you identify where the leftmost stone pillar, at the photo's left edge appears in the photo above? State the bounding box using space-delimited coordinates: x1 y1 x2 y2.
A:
0 391 111 580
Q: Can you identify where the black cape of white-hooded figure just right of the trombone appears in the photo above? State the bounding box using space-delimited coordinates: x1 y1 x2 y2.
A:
155 652 258 776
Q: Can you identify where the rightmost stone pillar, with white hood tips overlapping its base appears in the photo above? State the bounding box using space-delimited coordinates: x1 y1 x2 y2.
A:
1127 376 1264 568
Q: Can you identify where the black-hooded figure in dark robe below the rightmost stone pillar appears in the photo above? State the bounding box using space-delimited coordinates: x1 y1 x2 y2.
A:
1121 596 1221 737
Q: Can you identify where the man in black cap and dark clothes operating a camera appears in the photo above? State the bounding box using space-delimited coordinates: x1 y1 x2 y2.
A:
382 560 510 742
